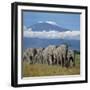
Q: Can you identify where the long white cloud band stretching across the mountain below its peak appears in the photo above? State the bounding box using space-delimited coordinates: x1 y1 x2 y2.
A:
24 28 80 39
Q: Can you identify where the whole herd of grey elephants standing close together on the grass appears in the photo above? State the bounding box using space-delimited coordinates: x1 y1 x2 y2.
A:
23 44 75 67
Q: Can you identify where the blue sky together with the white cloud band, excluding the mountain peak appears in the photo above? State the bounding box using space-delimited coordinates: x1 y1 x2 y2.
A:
23 11 80 39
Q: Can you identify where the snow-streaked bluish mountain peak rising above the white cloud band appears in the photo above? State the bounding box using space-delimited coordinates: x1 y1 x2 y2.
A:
28 22 68 32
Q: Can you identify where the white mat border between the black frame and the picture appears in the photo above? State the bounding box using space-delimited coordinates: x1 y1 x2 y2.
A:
18 6 85 84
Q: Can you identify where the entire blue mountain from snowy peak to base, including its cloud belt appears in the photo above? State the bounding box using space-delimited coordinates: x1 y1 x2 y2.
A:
23 22 80 51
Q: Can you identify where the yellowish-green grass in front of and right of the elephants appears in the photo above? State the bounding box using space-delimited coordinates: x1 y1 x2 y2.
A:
22 54 80 77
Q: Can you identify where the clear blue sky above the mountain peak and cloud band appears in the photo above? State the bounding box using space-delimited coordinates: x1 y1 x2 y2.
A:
23 11 80 30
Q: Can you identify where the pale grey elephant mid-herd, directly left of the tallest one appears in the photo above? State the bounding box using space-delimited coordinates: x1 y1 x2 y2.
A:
42 45 56 65
